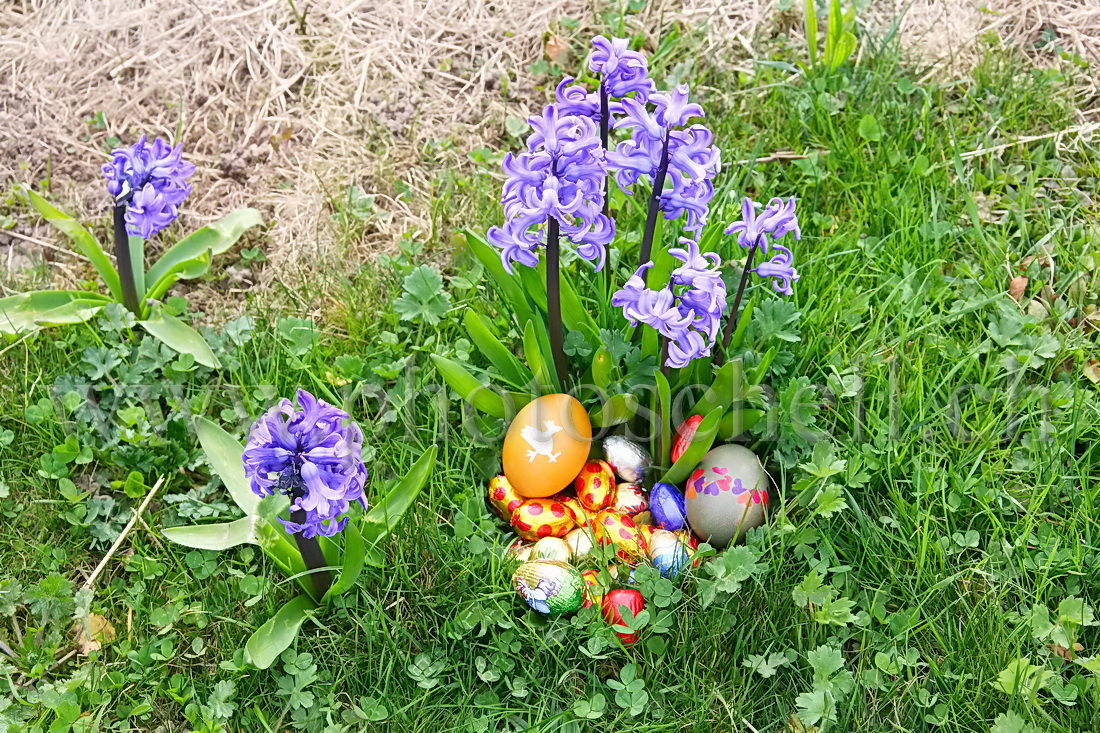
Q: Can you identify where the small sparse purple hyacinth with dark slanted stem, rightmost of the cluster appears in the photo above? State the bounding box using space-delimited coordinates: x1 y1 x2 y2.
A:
716 196 802 363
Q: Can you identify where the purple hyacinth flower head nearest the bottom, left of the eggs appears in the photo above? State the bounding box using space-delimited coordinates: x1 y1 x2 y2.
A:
244 390 366 538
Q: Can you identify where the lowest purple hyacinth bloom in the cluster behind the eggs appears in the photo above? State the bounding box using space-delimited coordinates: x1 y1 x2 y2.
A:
612 238 726 370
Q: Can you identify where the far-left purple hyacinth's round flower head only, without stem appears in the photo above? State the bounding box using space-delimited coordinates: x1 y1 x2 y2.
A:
103 135 195 239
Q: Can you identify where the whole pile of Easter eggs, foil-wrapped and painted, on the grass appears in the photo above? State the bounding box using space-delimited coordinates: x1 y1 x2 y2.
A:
488 394 769 643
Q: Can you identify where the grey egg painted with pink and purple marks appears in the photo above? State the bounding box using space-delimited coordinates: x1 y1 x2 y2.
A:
684 445 769 548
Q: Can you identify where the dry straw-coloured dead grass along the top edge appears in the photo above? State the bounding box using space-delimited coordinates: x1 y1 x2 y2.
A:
0 0 1100 308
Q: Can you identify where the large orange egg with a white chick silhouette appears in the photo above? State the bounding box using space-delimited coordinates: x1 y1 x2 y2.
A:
502 394 592 497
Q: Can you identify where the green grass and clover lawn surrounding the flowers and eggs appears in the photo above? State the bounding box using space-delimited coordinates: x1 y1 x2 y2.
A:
0 21 1100 733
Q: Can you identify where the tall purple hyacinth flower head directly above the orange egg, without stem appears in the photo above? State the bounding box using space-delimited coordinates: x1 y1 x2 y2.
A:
488 105 615 273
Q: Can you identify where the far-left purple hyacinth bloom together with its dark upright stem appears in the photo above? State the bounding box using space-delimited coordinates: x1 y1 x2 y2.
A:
103 135 195 315
